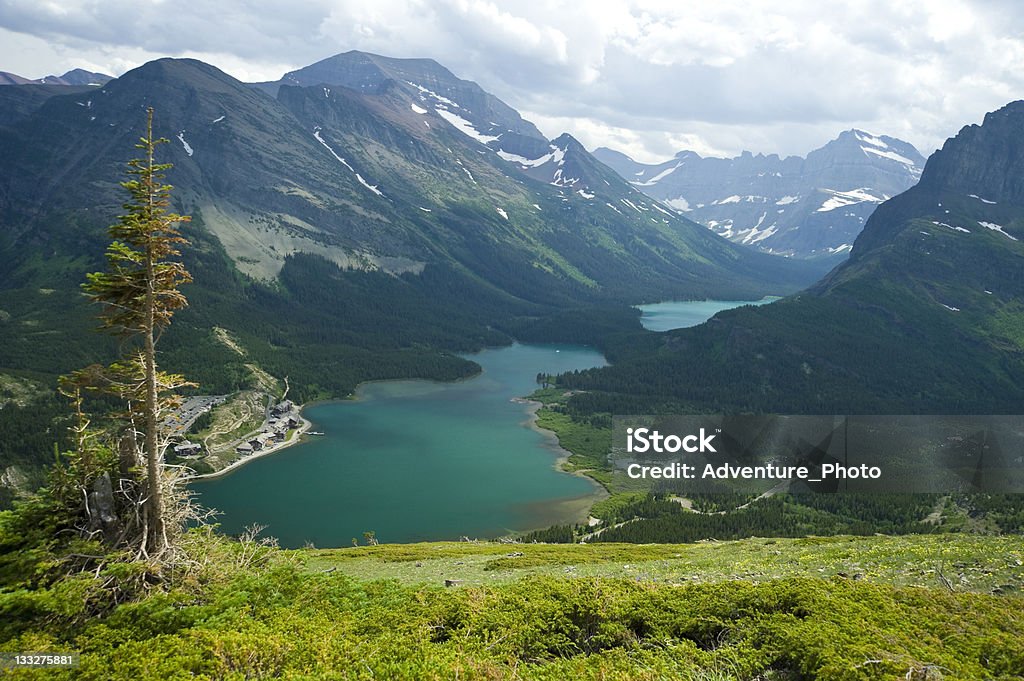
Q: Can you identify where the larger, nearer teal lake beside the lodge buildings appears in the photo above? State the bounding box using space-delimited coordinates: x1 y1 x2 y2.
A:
193 344 605 548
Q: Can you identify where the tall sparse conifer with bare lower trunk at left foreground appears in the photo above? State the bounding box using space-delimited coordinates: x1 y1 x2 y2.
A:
82 108 191 558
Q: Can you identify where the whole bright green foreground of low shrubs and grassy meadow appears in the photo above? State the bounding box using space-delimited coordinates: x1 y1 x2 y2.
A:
0 508 1024 680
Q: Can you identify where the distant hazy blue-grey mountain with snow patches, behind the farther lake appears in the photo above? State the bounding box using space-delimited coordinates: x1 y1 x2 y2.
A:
594 129 925 260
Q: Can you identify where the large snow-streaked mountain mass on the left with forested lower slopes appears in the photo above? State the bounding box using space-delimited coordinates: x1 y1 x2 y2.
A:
0 52 824 395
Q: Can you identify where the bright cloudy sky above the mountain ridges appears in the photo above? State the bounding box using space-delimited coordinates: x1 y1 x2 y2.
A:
0 0 1024 161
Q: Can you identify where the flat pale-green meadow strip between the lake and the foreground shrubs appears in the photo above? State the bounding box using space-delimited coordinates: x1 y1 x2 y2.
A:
311 535 1024 595
